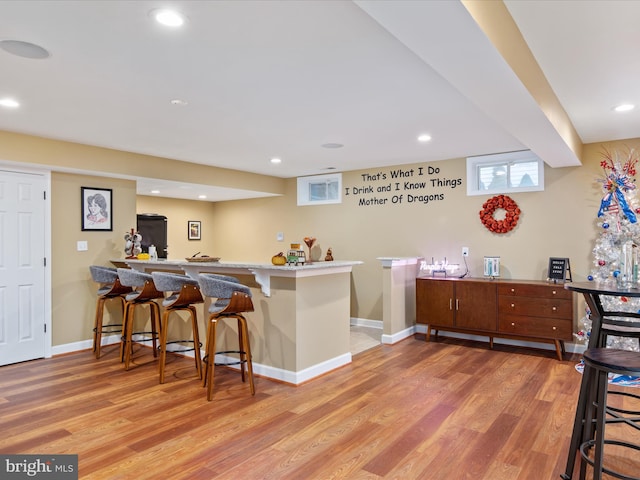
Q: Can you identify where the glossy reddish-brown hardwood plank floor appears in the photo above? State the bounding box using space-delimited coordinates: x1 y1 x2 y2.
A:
0 335 640 480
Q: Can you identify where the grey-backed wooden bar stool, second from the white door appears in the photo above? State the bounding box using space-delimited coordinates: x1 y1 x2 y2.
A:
118 268 164 370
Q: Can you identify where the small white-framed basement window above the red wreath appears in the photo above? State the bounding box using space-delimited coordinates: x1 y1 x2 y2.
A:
467 150 544 195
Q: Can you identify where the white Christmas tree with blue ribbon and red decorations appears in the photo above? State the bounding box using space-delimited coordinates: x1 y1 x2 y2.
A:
576 149 640 351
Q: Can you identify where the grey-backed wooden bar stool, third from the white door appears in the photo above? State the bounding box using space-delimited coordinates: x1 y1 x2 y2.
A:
151 272 204 383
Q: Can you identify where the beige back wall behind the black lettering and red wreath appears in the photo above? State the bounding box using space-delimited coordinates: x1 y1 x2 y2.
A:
205 141 616 320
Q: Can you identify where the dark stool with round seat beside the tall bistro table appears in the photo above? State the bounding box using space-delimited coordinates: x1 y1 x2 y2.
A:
579 348 640 480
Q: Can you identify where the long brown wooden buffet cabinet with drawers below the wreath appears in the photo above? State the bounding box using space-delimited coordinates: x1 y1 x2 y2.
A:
416 277 573 360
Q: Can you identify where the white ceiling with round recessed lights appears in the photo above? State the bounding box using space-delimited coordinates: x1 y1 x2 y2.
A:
0 0 640 201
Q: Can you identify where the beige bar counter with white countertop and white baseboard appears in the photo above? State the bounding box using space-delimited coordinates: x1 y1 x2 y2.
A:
111 259 362 385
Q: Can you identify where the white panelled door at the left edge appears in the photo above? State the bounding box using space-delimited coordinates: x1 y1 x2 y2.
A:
0 170 46 365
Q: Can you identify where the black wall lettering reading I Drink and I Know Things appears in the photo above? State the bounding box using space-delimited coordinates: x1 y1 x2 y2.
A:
344 166 462 207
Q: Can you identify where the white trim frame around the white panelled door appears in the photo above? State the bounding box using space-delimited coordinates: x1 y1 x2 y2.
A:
0 159 53 358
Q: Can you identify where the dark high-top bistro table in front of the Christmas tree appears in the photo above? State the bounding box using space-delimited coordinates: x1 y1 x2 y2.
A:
560 282 640 480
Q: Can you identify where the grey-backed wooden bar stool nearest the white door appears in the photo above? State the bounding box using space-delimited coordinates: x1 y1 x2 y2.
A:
89 265 132 358
